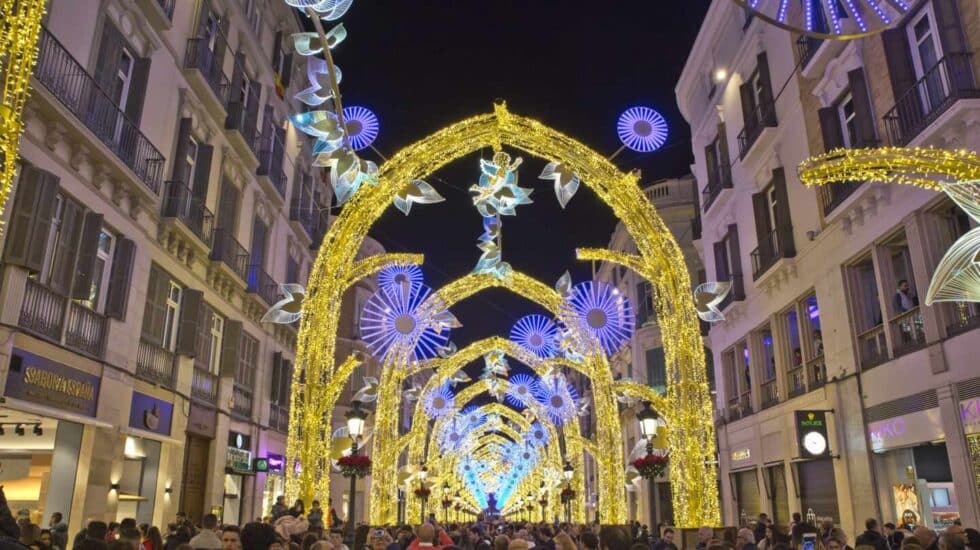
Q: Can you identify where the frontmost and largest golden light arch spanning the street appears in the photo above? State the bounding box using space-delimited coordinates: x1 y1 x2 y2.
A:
286 103 721 527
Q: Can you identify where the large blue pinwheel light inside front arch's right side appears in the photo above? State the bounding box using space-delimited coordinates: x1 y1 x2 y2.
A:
558 281 636 356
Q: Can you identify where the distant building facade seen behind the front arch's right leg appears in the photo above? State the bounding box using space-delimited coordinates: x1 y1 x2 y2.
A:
578 175 713 532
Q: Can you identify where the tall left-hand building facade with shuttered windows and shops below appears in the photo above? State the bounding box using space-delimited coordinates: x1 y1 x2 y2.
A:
0 0 381 533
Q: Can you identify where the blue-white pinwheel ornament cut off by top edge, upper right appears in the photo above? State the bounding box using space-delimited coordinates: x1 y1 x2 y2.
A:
735 0 921 40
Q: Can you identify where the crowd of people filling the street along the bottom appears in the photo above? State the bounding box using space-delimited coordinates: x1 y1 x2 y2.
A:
0 494 980 550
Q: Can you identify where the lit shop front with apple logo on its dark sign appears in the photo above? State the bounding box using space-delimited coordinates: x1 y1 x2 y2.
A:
116 391 174 524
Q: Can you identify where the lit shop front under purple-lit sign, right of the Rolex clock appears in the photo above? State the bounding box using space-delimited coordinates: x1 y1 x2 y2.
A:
868 407 960 529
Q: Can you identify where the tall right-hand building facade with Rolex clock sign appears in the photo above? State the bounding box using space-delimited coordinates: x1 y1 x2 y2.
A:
676 0 980 533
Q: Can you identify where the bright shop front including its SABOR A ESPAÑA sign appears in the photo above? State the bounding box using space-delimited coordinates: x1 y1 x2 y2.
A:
0 347 101 525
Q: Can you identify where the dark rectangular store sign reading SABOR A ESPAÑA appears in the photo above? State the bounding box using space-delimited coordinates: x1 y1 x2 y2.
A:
4 348 101 416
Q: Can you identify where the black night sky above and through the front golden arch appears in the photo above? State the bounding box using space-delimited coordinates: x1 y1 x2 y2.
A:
326 0 710 362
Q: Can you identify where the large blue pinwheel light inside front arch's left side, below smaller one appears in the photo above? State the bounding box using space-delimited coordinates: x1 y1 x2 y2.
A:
360 284 449 363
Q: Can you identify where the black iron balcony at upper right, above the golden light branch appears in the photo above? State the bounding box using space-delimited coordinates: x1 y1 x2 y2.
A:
884 53 980 146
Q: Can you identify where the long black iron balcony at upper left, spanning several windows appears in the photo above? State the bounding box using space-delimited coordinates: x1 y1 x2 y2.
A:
34 29 164 195
